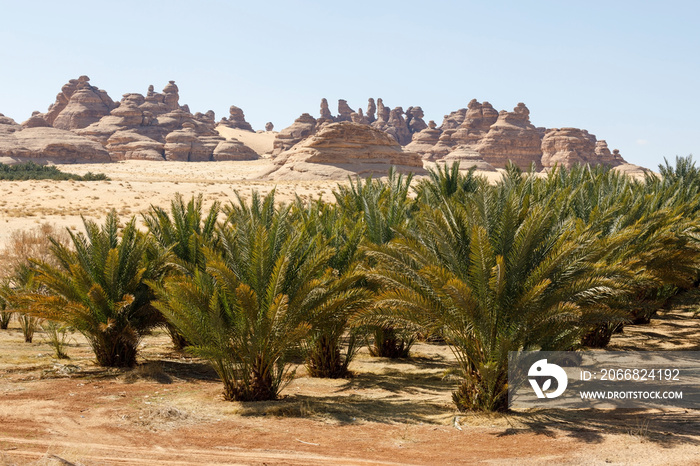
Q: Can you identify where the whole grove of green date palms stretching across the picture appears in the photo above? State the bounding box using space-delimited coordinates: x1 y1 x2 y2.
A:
0 157 700 411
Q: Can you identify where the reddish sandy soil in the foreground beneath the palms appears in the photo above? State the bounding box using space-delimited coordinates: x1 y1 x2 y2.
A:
0 296 700 465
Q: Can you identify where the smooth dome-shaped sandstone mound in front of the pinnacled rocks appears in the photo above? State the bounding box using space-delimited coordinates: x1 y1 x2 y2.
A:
268 122 423 179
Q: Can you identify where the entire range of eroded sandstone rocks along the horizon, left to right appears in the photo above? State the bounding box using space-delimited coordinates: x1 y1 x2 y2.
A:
0 76 636 170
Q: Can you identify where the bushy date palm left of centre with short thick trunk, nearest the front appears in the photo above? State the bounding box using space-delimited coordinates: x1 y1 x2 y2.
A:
156 192 360 401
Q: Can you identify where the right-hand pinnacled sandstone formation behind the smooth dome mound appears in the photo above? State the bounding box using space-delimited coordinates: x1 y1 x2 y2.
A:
273 98 624 173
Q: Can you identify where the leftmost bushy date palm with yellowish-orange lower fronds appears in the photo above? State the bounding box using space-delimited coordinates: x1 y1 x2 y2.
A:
18 211 164 367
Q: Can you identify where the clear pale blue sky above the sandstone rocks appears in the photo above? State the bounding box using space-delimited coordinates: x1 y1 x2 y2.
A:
0 0 700 168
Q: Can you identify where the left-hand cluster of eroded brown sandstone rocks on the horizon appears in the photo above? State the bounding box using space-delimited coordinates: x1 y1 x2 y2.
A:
0 76 252 161
